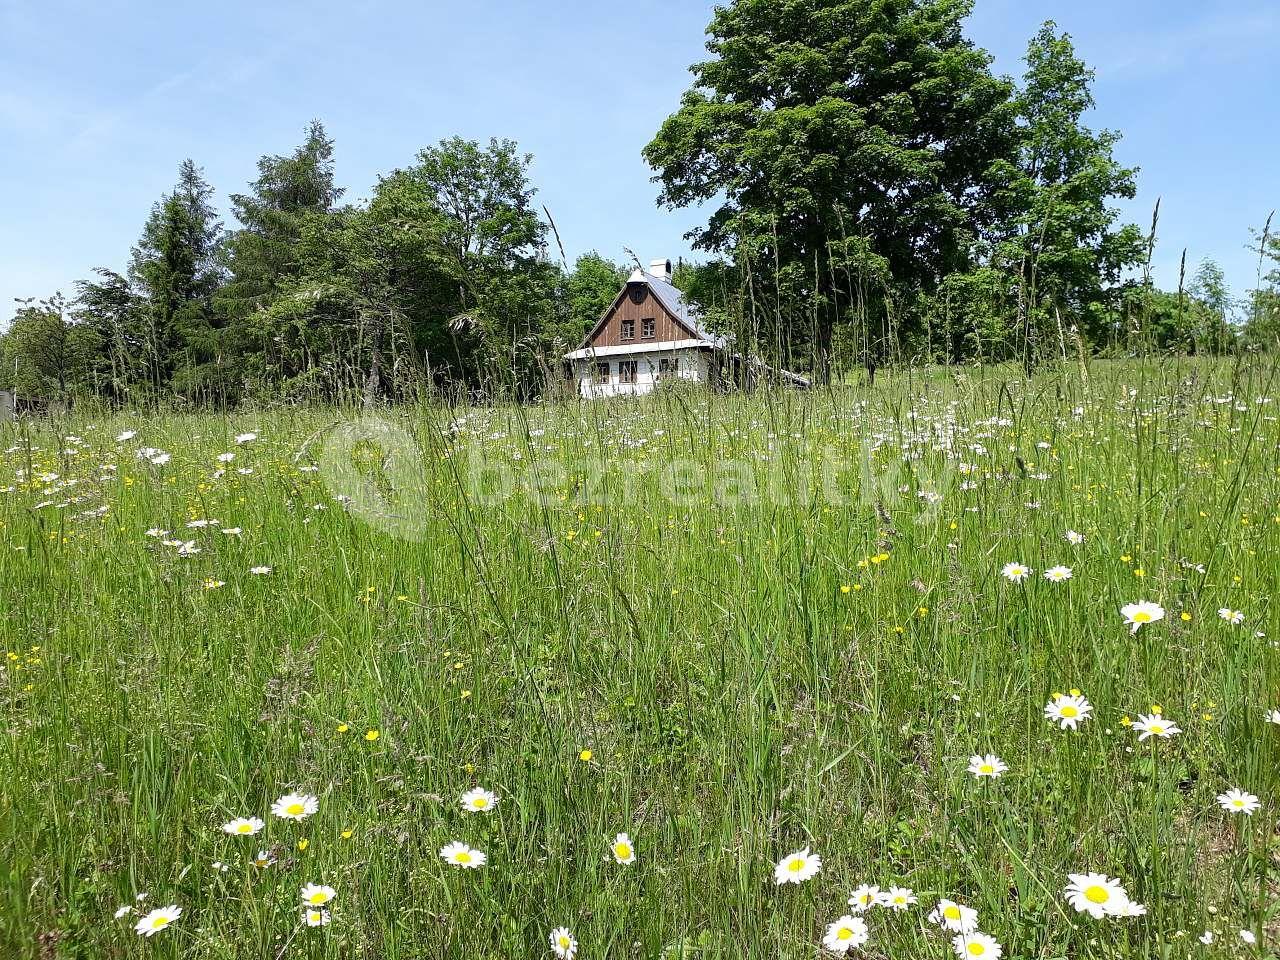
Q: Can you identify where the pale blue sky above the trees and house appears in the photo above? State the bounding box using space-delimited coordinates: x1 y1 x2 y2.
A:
0 0 1280 323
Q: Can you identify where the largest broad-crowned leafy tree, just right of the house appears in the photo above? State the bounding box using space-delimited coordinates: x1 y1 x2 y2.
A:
644 0 1014 378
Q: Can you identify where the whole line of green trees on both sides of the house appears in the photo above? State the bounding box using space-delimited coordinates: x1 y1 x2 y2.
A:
0 0 1280 404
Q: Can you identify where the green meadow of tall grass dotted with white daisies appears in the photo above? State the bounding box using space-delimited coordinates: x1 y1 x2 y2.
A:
0 357 1280 960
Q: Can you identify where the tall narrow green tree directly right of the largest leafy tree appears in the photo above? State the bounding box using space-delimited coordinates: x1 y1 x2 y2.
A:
996 20 1143 363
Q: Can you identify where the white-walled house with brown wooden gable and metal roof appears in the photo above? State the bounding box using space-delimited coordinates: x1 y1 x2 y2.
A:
564 260 732 398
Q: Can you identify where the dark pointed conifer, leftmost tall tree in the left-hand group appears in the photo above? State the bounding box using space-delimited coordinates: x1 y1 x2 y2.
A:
129 160 221 396
